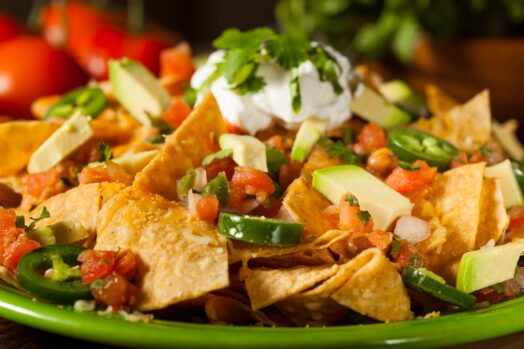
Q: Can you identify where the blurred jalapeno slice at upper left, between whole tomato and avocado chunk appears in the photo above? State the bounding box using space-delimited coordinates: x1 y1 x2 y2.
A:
44 87 108 119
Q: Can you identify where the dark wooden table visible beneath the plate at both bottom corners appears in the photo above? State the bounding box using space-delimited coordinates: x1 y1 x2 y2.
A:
0 319 524 349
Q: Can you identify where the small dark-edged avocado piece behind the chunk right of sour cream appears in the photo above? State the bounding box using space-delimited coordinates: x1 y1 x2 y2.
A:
378 80 427 115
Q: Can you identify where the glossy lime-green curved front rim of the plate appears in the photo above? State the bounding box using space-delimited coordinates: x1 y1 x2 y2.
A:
0 284 524 349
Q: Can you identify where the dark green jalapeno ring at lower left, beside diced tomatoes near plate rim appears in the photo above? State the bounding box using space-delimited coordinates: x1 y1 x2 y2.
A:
16 244 92 304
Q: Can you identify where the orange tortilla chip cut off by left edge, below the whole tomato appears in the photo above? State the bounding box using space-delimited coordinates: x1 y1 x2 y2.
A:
0 121 60 177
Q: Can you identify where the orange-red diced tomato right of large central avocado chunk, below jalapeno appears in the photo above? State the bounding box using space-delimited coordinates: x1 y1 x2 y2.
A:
386 160 437 194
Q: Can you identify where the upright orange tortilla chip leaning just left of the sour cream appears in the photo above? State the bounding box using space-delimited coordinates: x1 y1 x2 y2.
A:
133 93 227 200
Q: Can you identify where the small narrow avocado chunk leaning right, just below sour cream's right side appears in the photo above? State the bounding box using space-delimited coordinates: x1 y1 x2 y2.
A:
291 119 328 163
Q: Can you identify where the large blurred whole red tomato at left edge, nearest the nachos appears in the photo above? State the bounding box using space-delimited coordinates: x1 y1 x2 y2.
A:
0 36 88 118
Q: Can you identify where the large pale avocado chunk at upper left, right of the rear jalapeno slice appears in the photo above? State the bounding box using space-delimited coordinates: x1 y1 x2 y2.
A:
109 58 171 126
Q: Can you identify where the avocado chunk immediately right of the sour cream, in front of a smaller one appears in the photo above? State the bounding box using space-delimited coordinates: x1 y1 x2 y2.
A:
350 85 411 128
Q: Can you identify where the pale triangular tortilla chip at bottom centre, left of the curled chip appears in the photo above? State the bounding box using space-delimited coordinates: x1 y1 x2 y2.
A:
245 265 339 310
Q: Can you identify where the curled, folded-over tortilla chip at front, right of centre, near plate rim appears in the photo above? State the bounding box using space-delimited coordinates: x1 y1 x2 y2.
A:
277 248 412 326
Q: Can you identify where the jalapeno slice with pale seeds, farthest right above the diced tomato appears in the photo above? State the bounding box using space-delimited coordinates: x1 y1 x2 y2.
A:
388 128 459 171
